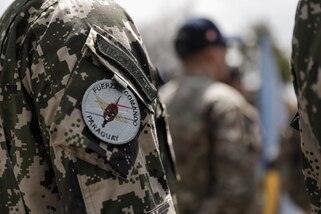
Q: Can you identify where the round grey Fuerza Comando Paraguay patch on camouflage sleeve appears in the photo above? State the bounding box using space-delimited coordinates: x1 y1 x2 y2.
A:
82 79 140 144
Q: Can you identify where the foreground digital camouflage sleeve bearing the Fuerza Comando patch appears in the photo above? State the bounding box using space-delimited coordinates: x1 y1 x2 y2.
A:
0 0 175 213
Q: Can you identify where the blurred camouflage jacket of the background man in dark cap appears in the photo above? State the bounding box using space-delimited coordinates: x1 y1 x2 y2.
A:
160 75 261 214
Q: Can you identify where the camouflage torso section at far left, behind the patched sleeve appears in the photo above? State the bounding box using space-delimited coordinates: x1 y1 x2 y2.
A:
0 1 60 213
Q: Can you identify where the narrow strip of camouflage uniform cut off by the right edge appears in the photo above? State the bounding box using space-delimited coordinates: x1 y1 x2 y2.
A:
291 0 321 213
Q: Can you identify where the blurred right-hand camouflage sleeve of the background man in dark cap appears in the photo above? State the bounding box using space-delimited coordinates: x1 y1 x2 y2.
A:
202 85 261 213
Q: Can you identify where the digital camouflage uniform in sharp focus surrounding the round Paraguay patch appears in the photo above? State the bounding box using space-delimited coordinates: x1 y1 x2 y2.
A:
0 0 175 214
